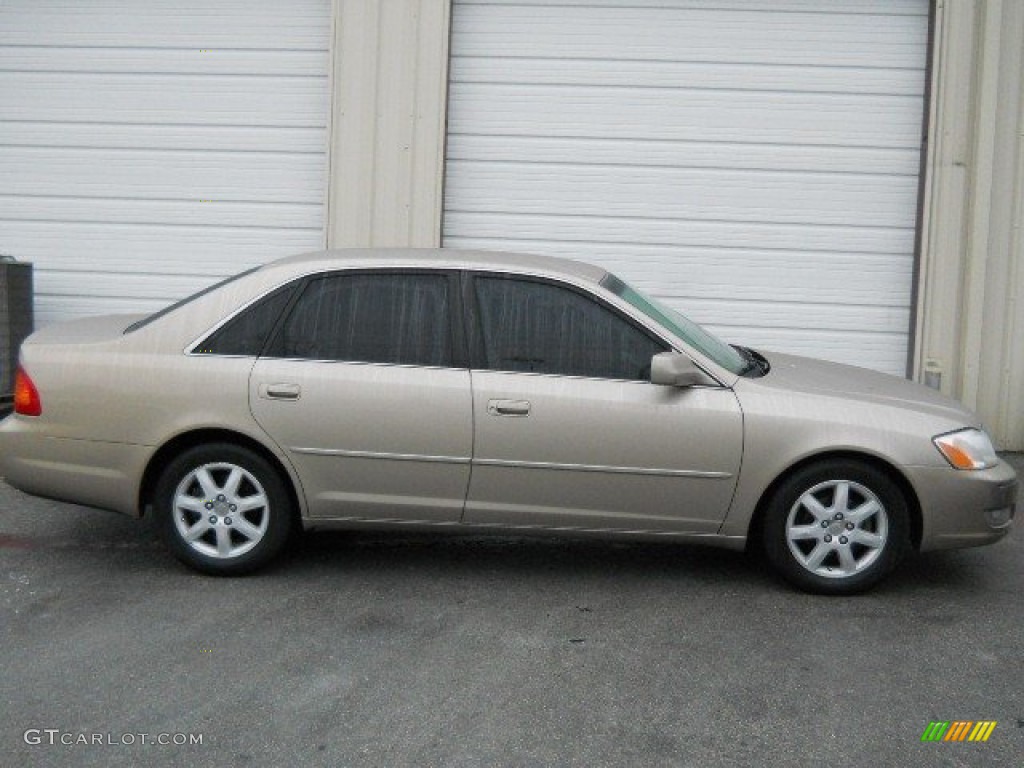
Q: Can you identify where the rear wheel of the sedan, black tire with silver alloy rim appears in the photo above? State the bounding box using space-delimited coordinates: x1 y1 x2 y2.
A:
154 443 294 575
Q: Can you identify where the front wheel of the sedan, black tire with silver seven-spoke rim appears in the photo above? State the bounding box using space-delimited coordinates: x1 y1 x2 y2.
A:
763 460 910 595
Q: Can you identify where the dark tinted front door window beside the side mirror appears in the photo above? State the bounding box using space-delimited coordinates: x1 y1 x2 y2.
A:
475 278 666 380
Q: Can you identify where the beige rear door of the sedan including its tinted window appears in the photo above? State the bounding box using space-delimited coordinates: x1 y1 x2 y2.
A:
249 270 473 522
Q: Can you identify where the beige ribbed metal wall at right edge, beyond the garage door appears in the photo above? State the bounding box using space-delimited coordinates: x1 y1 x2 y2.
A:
914 0 1024 451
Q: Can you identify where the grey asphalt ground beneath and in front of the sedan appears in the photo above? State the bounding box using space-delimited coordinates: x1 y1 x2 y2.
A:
0 455 1024 768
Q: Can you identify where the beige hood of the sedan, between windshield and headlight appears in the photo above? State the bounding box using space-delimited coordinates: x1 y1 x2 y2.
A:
746 352 979 426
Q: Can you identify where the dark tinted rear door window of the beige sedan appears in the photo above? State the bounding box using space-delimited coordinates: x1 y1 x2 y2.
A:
269 273 452 366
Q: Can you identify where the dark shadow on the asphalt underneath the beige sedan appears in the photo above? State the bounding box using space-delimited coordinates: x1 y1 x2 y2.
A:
0 487 1014 597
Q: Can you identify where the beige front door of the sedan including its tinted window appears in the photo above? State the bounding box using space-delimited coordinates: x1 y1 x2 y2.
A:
464 274 742 534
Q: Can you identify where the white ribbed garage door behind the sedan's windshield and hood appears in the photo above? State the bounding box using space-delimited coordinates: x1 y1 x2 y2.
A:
444 0 928 375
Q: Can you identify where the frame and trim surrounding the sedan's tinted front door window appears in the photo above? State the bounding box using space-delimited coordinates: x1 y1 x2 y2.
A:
462 269 679 384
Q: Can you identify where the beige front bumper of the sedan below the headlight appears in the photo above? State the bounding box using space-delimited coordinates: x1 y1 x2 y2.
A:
907 460 1019 552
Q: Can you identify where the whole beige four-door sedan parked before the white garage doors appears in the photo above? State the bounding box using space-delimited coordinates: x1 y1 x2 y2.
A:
0 250 1017 594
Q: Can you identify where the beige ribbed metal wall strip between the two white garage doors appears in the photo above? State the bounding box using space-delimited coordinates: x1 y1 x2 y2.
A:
328 0 451 248
